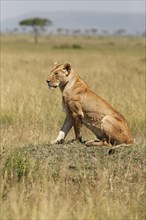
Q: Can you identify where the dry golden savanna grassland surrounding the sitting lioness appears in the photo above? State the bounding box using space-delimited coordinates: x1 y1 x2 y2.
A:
0 35 146 220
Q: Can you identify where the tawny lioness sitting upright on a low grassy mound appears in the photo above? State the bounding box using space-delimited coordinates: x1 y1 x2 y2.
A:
47 63 134 146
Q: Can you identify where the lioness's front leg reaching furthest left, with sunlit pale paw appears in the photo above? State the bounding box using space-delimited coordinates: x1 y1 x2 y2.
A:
51 115 73 144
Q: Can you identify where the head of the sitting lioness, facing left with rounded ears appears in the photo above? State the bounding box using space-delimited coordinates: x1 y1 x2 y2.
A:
46 63 71 88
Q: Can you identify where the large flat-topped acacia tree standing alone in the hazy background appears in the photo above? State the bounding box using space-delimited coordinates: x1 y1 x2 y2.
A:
19 18 53 44
